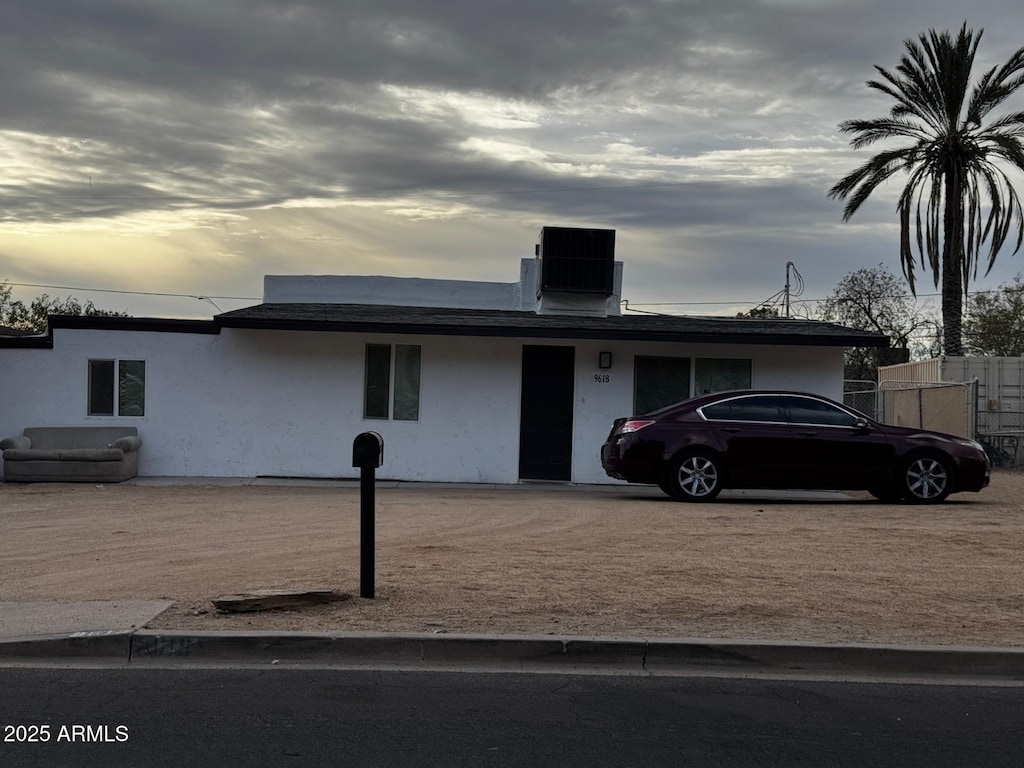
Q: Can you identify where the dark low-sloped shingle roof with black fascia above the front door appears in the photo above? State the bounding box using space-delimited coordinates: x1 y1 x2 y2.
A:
213 304 889 347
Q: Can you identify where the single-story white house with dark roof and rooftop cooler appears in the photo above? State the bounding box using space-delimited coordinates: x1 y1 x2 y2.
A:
0 227 888 483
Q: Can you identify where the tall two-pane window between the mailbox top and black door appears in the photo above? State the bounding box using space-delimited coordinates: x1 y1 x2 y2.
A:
362 344 421 421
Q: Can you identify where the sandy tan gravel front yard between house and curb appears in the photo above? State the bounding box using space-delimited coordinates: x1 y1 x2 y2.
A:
0 471 1024 646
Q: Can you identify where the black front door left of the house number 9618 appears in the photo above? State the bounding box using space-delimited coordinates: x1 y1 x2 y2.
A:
519 345 575 480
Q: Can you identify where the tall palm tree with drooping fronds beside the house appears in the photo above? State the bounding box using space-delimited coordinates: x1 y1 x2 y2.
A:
828 23 1024 355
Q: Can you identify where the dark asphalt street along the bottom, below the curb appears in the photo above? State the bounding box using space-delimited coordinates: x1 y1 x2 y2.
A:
0 667 1024 768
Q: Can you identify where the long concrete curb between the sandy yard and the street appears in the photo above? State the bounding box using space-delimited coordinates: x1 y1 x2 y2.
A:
0 630 1024 682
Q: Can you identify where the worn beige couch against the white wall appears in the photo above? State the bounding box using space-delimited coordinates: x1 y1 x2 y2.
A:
0 427 142 482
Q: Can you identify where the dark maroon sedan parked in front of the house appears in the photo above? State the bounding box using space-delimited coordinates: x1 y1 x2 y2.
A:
601 390 989 504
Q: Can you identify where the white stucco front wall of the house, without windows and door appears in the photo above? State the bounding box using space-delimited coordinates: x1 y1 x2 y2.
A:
0 329 843 482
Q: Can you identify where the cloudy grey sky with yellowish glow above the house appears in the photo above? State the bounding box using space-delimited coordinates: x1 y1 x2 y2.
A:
0 0 1024 317
